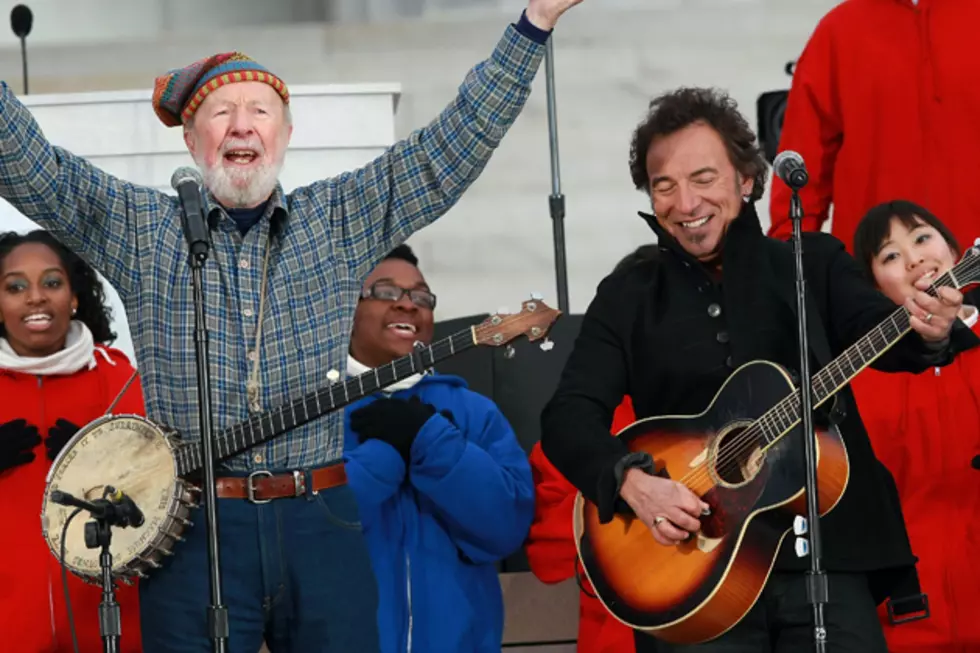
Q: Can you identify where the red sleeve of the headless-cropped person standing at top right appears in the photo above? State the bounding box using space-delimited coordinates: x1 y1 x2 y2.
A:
769 14 843 240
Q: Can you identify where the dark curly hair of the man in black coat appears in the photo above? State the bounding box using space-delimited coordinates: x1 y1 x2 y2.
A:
630 88 768 201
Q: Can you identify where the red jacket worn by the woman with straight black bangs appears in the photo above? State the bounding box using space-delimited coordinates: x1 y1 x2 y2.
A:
851 318 980 653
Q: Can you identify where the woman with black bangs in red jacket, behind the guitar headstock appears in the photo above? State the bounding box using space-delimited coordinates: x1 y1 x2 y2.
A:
851 201 980 653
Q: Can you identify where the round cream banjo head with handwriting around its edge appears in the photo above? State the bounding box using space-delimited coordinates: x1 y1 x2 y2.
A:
41 415 189 580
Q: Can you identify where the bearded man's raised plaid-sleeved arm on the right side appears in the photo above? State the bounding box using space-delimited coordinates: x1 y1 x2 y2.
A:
297 7 579 277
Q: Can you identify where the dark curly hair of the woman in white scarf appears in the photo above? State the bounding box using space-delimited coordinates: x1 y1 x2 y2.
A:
0 229 116 345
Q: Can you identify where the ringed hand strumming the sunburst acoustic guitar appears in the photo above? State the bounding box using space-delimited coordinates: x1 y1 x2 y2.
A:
619 469 708 546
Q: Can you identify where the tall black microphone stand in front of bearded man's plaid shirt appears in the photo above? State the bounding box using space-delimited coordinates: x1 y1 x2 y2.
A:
184 209 229 653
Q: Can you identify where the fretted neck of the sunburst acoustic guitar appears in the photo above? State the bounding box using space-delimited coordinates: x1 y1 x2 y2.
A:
757 261 964 444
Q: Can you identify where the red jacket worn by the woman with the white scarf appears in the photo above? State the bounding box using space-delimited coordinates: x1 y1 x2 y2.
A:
0 345 144 653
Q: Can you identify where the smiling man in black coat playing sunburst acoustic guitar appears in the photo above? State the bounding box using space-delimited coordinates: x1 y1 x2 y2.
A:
542 88 976 653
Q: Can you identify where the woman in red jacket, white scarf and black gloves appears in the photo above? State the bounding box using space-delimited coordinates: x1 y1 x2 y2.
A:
0 231 144 653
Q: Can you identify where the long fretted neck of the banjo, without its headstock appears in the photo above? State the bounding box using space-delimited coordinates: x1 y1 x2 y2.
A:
176 327 477 476
